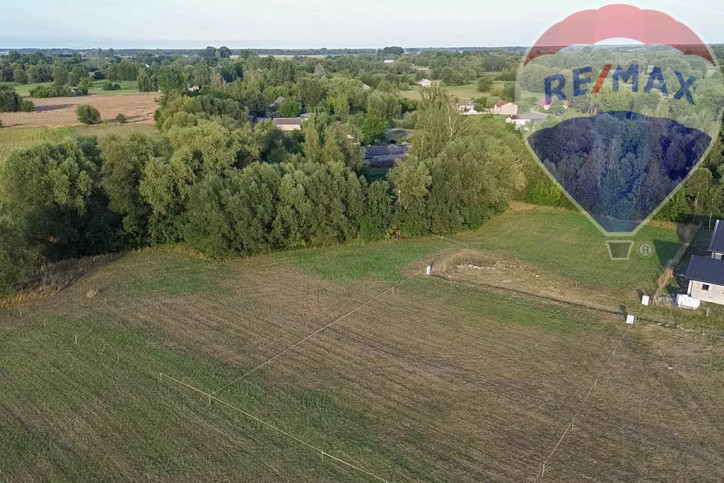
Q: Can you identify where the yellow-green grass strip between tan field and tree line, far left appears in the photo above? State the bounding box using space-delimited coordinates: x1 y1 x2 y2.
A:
0 123 155 163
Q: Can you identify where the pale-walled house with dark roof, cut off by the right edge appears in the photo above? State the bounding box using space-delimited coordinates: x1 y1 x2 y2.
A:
685 220 724 305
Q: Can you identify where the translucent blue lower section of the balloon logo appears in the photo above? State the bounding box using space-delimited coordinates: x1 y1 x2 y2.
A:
528 111 711 233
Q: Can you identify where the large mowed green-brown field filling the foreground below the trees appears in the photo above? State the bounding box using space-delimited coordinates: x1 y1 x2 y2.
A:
0 210 724 481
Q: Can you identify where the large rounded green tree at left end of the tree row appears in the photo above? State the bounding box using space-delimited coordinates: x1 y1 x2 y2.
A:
0 138 120 260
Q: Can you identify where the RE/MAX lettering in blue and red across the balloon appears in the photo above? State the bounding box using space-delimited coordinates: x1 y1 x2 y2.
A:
545 64 696 104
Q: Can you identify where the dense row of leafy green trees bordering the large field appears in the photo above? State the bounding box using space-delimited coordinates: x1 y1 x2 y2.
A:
0 88 522 291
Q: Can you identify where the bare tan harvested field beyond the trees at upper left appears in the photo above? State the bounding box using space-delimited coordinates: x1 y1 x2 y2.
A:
0 92 159 127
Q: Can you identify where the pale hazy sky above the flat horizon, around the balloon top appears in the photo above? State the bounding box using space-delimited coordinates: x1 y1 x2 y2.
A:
0 0 724 49
